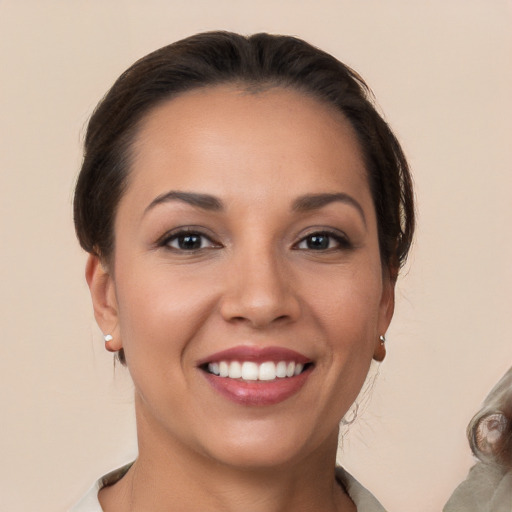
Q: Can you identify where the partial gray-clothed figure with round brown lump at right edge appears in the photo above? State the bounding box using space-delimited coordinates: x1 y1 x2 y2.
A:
444 368 512 512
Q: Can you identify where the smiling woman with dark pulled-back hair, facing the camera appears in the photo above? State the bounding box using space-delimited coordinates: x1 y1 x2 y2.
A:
74 32 414 512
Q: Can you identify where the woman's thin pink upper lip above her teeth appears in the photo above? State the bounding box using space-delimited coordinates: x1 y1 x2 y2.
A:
197 345 312 366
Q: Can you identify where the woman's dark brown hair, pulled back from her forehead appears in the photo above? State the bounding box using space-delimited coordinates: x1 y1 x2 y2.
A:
74 32 414 279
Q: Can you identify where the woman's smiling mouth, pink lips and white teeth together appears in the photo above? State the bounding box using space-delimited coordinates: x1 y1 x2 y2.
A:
198 346 314 405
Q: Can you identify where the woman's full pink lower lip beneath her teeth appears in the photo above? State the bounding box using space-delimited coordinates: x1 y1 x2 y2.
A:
203 368 312 406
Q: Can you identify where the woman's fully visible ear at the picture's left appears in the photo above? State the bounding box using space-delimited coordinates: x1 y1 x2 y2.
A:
85 254 123 352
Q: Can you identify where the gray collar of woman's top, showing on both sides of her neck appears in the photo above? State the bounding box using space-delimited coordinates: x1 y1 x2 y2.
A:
69 464 386 512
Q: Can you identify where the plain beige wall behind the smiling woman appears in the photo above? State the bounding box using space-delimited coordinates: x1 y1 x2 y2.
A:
0 0 512 512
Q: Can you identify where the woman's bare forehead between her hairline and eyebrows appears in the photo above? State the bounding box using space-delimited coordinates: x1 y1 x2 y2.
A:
128 86 368 208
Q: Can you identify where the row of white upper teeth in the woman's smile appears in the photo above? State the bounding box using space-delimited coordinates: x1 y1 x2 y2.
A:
208 361 304 381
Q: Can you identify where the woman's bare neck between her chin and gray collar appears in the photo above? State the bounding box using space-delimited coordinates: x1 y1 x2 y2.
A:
100 398 356 512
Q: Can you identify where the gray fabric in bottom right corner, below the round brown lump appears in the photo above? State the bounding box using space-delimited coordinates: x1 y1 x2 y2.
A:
443 462 512 512
